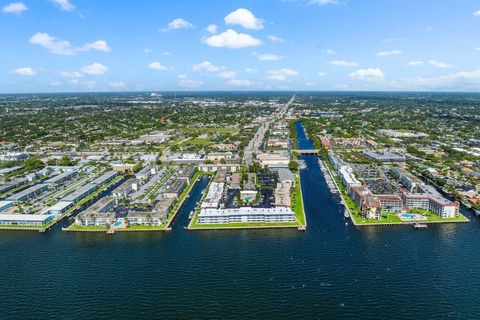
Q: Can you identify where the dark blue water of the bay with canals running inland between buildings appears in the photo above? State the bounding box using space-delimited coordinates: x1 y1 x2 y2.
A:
0 127 480 319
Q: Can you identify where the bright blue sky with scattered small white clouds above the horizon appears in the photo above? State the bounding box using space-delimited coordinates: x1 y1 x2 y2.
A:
0 0 480 93
